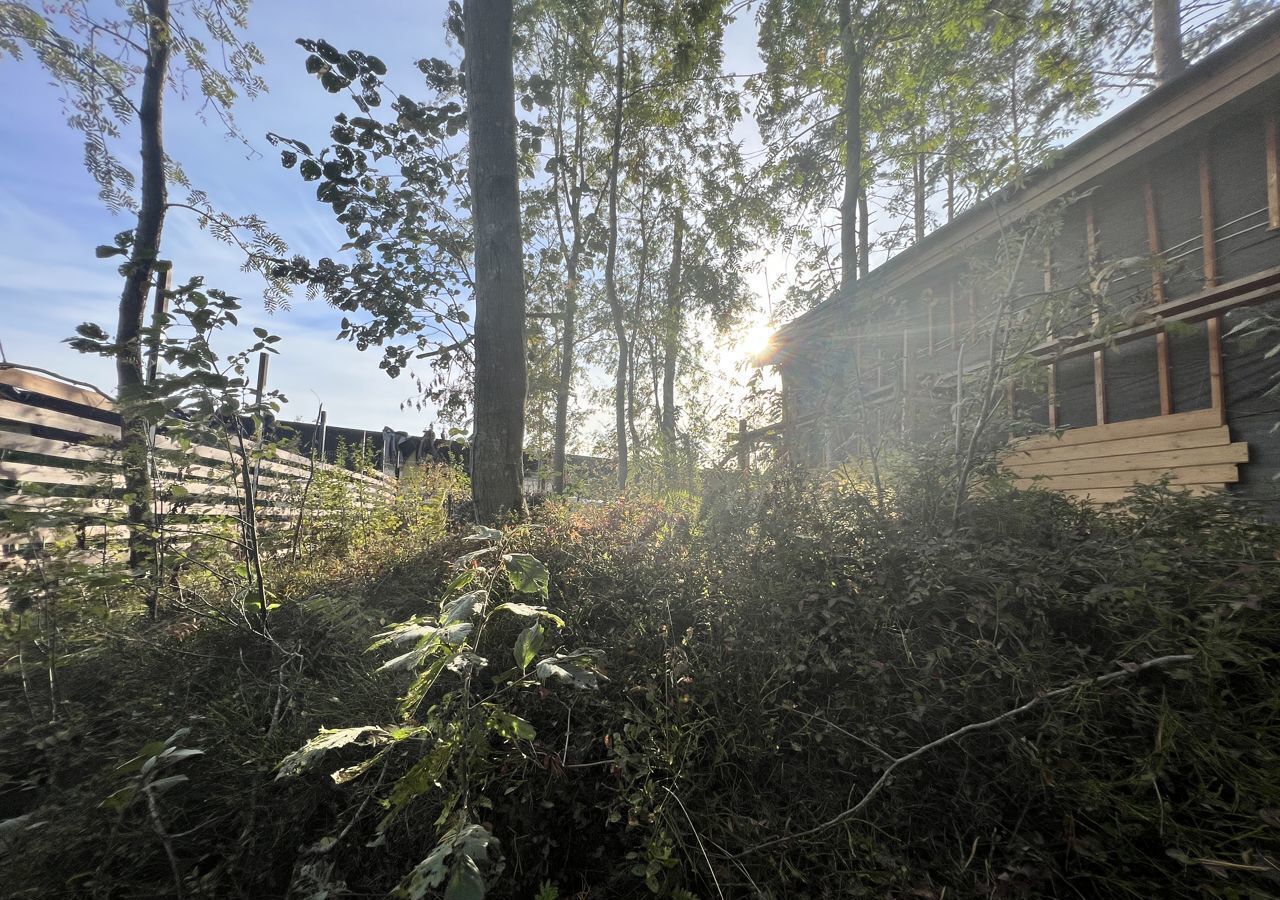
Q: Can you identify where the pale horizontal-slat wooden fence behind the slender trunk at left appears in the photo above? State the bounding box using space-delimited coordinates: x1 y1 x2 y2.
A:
0 365 396 566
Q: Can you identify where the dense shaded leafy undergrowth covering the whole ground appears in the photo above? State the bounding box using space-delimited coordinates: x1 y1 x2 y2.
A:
0 476 1280 900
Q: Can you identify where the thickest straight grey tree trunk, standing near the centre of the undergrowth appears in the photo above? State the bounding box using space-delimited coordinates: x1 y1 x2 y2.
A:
462 0 529 522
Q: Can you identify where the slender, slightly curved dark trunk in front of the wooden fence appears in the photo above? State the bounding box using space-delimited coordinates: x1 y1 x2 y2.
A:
115 0 170 588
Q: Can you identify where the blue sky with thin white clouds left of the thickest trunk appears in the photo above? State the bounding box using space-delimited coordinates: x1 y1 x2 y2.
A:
0 0 481 431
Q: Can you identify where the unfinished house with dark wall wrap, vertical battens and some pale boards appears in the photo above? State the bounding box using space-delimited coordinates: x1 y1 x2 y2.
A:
763 15 1280 502
